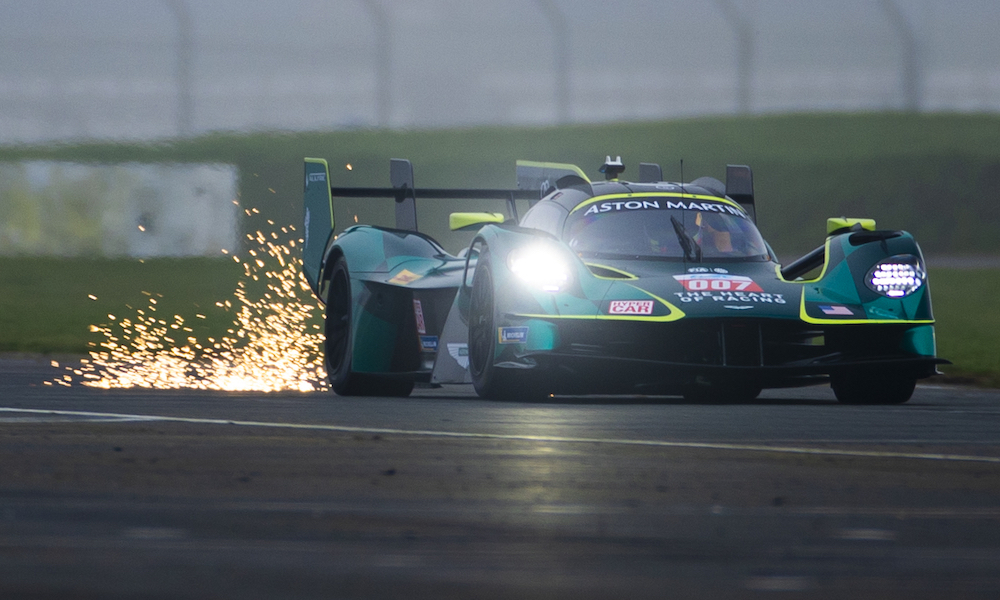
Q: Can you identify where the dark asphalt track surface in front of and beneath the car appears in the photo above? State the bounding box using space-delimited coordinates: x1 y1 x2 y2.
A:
0 358 1000 600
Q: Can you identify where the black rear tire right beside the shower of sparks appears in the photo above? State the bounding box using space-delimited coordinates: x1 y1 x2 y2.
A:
323 257 413 396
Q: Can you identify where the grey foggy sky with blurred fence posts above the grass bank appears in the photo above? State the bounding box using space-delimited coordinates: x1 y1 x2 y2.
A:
0 0 1000 144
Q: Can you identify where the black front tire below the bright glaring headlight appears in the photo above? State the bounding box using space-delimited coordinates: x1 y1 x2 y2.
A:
469 251 545 401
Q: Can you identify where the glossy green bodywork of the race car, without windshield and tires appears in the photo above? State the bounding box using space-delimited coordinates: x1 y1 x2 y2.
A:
304 159 946 393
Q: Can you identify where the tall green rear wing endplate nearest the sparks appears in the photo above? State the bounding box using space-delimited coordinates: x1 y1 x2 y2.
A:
302 158 334 292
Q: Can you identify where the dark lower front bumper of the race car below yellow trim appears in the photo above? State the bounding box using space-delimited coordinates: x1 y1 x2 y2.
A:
496 318 948 393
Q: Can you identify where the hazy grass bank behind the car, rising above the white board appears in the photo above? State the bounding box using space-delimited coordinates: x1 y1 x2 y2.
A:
0 113 1000 256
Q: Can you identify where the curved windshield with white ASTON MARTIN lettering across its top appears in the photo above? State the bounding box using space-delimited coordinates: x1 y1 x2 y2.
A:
563 197 770 262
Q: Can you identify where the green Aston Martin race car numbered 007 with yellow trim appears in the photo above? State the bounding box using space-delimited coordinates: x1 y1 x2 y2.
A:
303 156 947 404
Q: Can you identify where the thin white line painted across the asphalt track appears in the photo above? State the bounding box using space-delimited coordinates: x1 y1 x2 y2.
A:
0 407 1000 464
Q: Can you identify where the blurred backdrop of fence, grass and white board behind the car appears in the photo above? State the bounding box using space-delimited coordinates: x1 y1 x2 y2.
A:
0 0 1000 385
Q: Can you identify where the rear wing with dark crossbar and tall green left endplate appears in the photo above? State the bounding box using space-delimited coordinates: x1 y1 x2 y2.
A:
302 158 538 289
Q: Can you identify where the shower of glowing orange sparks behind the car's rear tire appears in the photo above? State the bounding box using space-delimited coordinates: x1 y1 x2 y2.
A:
66 223 326 392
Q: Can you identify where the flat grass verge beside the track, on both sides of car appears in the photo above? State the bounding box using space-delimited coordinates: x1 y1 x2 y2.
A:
0 258 1000 387
